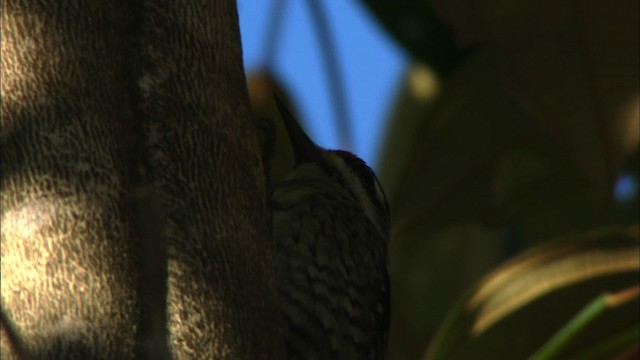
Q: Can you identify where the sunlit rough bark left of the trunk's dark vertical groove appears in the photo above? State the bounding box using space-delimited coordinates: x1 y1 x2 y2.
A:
1 1 140 358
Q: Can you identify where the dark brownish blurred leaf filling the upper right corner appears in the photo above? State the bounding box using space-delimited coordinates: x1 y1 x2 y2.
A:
431 0 640 196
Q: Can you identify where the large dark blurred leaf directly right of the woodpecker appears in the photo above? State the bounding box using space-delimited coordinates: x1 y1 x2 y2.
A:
380 51 635 359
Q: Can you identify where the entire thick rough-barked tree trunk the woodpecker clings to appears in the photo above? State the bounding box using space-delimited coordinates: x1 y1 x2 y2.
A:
1 0 281 359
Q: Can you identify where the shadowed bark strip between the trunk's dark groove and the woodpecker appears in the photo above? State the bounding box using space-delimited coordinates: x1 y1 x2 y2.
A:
138 0 276 359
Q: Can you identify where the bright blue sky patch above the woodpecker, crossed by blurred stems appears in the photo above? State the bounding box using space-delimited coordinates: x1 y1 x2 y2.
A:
238 0 408 167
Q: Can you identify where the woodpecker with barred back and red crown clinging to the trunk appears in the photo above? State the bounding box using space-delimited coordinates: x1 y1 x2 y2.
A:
272 96 390 359
